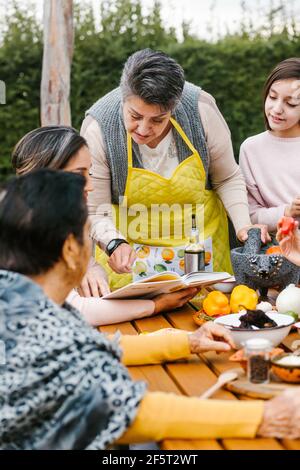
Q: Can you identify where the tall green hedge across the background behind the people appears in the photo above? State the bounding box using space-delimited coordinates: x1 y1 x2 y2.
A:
0 0 300 179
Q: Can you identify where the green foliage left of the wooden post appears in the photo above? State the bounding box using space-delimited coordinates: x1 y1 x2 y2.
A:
0 2 42 179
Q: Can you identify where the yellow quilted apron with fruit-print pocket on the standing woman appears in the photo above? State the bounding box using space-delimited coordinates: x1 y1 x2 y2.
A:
95 118 232 290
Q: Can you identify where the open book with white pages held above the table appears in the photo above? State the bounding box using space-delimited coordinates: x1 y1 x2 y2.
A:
103 271 231 299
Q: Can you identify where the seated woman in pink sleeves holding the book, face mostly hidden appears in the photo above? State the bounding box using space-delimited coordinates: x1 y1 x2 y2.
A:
12 126 198 326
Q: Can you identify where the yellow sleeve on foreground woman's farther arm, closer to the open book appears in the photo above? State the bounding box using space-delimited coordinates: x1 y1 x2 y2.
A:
120 330 191 366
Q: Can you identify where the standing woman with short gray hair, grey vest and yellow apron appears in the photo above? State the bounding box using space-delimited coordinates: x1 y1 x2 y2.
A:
81 49 268 288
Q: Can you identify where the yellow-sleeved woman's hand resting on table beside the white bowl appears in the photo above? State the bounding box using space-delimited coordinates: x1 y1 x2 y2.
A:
189 321 235 354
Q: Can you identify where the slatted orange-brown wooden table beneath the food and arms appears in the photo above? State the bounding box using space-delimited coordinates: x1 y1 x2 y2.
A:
101 305 300 450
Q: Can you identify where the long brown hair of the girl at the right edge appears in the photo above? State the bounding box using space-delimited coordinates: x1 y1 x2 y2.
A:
263 57 300 130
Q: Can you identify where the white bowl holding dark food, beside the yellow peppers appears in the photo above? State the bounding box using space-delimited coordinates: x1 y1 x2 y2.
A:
214 312 295 349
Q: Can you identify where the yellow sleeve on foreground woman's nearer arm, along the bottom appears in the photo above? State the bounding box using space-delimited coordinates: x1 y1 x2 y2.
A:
118 392 263 444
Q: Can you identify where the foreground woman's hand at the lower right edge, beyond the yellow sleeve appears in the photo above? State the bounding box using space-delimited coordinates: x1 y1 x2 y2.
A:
257 391 300 439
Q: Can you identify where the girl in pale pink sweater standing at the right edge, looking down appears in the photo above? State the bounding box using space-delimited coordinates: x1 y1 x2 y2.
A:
239 58 300 232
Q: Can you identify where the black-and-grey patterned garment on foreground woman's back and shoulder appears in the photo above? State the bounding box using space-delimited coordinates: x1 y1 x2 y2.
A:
0 270 146 449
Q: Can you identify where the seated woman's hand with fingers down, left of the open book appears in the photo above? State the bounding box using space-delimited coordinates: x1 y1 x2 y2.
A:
78 262 110 297
